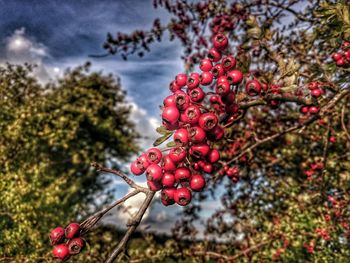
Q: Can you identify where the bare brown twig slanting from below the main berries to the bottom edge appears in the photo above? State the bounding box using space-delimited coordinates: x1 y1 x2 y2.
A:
106 190 155 263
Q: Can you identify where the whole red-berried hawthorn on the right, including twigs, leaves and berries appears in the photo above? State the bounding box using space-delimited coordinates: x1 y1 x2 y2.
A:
51 0 350 262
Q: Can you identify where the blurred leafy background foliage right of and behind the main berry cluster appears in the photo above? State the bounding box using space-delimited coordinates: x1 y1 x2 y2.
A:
100 0 350 262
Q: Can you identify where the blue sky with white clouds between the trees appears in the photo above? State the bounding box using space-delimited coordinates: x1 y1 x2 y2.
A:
0 0 223 235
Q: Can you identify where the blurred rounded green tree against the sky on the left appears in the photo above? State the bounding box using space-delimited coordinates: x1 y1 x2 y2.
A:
0 64 138 262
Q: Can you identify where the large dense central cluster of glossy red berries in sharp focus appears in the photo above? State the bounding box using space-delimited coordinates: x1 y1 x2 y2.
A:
130 33 261 206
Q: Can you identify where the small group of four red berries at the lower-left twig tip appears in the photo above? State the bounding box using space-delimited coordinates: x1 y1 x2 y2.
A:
49 223 85 261
